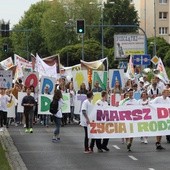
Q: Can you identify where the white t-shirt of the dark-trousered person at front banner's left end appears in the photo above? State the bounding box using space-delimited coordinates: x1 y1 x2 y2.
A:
80 99 92 127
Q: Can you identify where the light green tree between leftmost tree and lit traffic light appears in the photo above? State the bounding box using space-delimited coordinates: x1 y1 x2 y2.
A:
41 0 67 53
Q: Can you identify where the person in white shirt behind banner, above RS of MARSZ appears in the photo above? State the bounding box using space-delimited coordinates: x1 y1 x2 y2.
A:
122 89 138 152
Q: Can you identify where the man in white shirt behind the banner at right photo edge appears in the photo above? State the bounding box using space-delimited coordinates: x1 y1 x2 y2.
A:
150 89 170 150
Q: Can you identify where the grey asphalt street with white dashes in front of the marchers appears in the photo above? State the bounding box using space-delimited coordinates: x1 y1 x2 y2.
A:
8 125 170 170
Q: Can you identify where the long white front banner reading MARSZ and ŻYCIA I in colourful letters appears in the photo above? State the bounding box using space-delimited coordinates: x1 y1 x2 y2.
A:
88 104 170 138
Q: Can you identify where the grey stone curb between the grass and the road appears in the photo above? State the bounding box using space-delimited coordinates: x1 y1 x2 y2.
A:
0 129 27 170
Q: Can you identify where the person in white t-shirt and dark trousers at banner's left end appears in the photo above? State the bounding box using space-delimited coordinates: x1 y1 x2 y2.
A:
80 91 93 153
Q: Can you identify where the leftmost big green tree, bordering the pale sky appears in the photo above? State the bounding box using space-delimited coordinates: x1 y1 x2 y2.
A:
12 1 50 56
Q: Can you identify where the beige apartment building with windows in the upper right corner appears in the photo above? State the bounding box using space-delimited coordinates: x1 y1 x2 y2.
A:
131 0 170 43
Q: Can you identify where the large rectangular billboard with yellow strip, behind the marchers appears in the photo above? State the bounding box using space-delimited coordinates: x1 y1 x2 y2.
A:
114 34 145 59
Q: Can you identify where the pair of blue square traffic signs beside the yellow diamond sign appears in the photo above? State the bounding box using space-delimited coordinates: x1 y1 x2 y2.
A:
133 54 151 65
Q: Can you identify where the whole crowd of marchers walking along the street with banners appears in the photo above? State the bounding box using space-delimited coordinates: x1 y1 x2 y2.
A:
0 72 170 153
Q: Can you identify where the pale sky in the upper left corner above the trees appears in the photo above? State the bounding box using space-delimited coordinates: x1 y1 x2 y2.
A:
0 0 41 28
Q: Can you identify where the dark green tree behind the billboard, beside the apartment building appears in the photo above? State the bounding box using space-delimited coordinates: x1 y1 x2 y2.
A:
103 0 139 48
